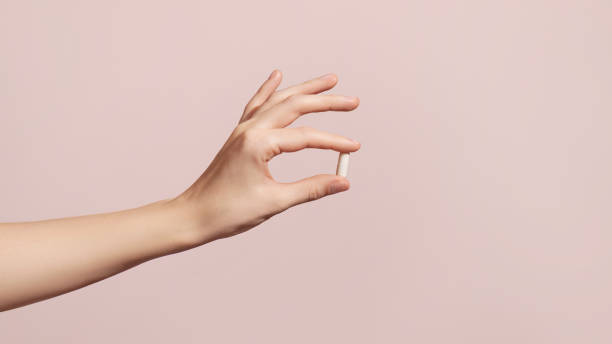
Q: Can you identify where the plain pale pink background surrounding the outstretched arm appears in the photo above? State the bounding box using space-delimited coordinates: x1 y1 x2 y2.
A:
0 0 612 343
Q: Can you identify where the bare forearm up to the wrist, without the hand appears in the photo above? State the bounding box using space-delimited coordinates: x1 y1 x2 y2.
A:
0 196 200 310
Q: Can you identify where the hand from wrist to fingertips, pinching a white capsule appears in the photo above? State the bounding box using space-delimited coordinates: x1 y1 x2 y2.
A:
175 70 360 245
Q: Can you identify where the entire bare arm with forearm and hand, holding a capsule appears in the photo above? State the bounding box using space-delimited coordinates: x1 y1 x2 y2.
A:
0 70 360 310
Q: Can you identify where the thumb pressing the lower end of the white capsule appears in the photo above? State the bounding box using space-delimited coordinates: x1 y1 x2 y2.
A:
282 174 350 208
